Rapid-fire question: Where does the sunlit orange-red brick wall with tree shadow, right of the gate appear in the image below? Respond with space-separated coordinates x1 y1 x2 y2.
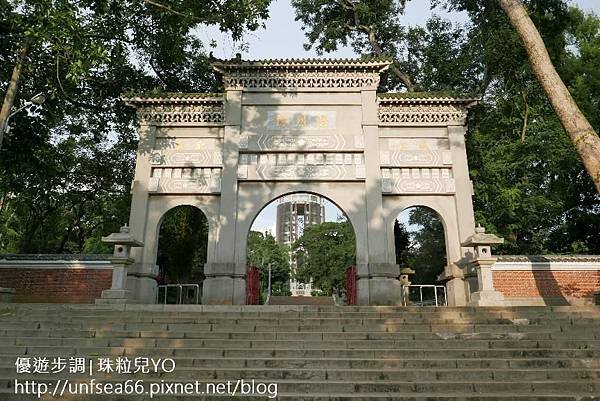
493 270 600 298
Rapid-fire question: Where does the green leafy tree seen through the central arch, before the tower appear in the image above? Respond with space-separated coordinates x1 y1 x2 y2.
292 221 356 295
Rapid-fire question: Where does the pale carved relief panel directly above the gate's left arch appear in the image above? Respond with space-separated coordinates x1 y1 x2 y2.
148 168 221 194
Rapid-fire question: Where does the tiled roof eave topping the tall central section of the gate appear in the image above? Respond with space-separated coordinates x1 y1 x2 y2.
211 57 392 75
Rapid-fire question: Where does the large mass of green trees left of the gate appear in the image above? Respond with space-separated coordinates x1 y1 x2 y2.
0 0 270 253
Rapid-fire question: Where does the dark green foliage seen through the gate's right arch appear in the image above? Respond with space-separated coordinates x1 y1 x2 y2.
394 207 447 284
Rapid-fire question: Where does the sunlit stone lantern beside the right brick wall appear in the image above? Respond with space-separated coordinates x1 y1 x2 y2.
461 226 504 306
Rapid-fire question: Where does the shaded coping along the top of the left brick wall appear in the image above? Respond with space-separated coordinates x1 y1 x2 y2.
0 254 112 269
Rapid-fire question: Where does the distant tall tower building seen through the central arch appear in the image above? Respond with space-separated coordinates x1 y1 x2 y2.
276 194 325 296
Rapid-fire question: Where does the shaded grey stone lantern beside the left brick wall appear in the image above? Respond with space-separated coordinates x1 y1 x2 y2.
96 224 144 304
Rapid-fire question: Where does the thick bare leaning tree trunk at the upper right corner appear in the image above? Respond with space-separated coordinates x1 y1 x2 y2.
498 0 600 193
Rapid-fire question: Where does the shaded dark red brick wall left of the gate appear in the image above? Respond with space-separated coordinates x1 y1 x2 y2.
0 268 112 303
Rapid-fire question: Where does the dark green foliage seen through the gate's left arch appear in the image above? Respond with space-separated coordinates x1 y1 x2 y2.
157 206 208 283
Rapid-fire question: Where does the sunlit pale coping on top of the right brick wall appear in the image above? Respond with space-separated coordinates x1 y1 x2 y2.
492 255 600 271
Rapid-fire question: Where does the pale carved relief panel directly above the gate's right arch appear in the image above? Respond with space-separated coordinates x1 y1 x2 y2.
381 168 456 194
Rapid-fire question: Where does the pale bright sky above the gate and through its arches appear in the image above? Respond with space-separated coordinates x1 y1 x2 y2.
198 0 600 234
